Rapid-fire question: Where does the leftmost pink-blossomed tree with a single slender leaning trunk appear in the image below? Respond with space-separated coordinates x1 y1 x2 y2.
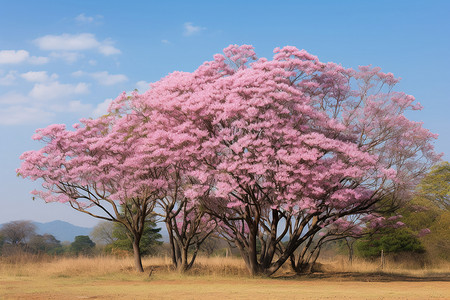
17 104 164 272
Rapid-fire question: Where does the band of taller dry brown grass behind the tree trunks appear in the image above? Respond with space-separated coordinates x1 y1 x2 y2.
0 253 450 277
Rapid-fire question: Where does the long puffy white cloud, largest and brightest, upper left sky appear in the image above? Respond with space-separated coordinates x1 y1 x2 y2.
34 33 120 55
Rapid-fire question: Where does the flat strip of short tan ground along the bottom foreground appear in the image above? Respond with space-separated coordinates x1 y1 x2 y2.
0 274 450 299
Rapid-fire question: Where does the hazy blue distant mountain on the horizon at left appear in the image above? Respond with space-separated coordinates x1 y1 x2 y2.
33 221 92 242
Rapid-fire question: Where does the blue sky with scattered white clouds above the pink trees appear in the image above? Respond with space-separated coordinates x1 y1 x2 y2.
0 0 450 226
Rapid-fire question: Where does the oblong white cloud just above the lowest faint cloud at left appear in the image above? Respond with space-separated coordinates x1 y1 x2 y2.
29 81 89 100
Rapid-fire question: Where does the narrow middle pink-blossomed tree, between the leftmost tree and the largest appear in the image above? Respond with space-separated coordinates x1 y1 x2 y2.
111 91 217 272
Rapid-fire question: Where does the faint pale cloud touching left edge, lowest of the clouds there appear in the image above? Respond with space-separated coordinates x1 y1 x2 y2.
0 106 54 125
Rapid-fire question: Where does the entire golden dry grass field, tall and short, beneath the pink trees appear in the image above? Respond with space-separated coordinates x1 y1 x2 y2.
0 257 450 300
